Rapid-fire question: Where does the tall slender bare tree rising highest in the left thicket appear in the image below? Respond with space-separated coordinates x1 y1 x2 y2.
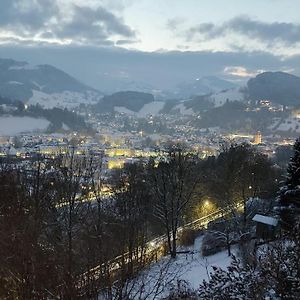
54 147 98 299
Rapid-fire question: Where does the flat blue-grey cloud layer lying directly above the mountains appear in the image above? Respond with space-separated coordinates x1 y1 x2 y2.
0 46 300 91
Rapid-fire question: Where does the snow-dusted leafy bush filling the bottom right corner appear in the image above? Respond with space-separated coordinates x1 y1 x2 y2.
198 223 300 300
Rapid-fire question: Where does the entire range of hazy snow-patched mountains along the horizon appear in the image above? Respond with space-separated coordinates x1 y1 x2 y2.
0 58 300 115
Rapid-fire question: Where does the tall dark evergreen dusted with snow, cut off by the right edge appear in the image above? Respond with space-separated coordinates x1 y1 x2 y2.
278 138 300 229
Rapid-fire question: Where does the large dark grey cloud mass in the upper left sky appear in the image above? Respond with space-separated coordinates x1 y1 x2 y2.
0 0 136 46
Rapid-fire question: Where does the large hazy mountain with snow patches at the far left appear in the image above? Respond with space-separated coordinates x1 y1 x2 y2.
0 59 100 107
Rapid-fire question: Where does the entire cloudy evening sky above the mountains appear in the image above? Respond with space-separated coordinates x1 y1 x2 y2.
0 0 300 88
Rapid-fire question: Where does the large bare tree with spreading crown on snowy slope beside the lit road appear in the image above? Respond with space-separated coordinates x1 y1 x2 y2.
151 148 200 258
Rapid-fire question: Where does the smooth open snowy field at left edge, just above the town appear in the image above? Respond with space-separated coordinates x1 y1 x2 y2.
0 117 50 135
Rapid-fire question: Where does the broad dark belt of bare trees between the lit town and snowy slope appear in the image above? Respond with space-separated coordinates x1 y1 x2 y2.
0 145 282 299
